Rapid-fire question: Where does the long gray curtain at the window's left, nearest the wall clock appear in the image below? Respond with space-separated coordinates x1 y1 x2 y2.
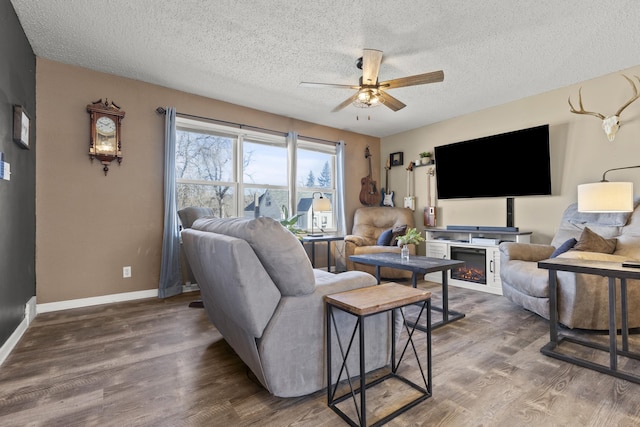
158 107 182 298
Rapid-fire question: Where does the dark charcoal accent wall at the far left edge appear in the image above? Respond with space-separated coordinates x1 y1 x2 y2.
0 0 36 346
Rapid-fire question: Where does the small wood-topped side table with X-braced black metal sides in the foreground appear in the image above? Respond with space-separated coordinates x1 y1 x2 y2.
324 283 432 426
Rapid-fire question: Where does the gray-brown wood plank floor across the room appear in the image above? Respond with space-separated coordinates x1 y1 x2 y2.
0 283 640 426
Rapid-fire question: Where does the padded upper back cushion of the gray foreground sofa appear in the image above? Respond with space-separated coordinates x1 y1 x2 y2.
192 217 316 296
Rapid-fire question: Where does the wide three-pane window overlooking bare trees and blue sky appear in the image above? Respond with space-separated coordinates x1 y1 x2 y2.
176 117 336 231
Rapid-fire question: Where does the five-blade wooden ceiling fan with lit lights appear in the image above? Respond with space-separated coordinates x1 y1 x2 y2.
300 49 444 112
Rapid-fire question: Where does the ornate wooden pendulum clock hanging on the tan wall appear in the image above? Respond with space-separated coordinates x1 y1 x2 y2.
87 98 124 176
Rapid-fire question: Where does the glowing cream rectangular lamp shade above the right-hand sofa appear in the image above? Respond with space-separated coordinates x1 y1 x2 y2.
578 182 633 212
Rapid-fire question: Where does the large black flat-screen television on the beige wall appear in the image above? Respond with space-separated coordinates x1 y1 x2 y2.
434 125 551 199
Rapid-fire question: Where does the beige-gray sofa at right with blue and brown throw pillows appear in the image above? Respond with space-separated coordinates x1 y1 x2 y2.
500 201 640 330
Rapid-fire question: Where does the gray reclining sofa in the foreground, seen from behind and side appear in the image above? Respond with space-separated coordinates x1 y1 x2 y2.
182 218 399 397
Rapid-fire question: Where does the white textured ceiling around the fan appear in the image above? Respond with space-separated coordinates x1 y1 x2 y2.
11 0 640 137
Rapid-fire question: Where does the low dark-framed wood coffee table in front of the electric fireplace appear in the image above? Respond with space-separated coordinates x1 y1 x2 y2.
349 252 464 329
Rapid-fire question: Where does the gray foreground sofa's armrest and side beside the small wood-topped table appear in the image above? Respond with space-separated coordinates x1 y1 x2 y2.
258 271 400 397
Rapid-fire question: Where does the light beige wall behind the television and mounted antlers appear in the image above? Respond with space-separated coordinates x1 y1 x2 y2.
381 66 640 250
